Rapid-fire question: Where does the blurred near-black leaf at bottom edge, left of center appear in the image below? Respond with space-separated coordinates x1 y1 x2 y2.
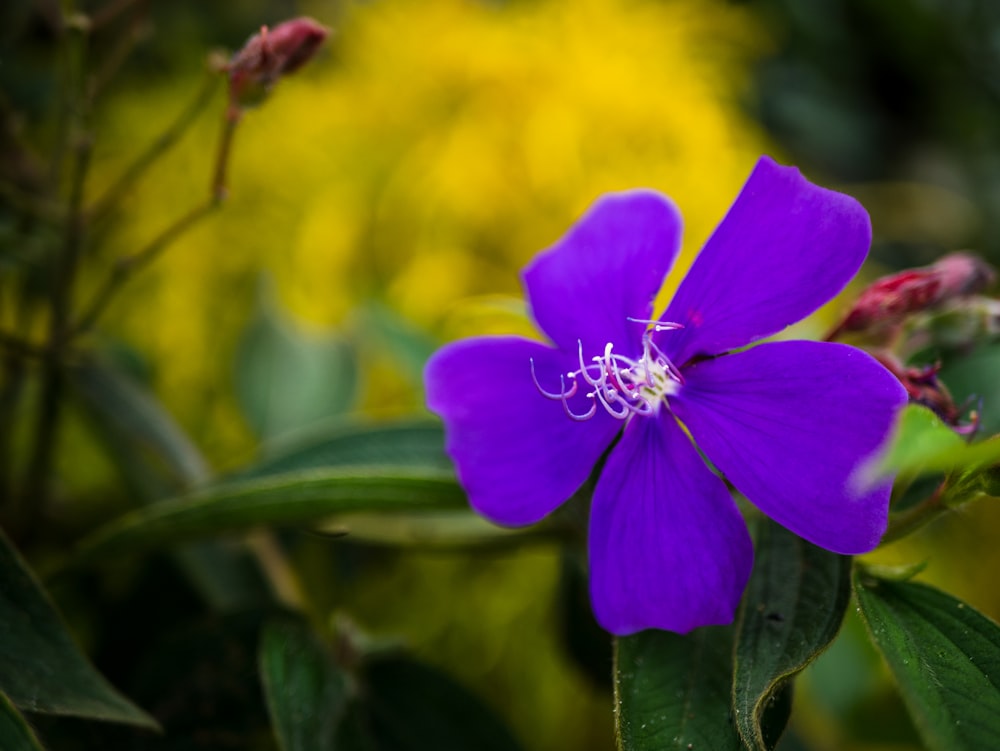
337 656 521 751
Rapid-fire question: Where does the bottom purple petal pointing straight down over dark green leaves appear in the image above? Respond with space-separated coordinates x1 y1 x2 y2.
590 411 753 635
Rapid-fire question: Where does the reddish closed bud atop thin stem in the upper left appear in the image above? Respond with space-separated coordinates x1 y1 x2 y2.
227 17 330 108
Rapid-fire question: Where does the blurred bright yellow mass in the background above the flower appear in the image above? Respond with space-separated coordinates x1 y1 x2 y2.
92 0 767 464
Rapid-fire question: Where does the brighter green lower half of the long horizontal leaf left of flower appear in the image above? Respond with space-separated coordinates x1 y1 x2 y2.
74 467 466 559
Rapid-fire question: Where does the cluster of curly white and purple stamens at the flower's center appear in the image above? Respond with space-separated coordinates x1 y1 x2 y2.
531 319 684 420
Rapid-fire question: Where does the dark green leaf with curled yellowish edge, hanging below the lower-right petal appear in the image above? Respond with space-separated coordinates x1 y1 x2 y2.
733 519 851 751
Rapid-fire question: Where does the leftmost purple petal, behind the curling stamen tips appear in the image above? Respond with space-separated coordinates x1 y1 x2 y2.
424 337 621 526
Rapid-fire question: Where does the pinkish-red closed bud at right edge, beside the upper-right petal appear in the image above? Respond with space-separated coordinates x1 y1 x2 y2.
840 253 995 331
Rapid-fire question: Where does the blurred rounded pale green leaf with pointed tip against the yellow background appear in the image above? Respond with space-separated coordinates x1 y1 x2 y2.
236 301 357 440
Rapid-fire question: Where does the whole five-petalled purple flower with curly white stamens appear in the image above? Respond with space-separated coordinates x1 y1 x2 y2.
425 157 906 634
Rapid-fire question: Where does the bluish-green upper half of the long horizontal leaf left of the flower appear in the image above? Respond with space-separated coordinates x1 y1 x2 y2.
229 420 452 479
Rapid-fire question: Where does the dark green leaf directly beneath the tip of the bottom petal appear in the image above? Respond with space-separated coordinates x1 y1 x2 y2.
615 626 743 751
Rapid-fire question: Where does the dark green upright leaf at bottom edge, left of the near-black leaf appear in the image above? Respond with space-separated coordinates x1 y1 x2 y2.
258 620 348 751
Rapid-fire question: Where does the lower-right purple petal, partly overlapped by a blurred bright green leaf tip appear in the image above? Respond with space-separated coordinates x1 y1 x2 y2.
671 342 906 554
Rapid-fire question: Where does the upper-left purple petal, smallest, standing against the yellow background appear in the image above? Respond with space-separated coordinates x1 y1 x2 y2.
523 190 681 355
